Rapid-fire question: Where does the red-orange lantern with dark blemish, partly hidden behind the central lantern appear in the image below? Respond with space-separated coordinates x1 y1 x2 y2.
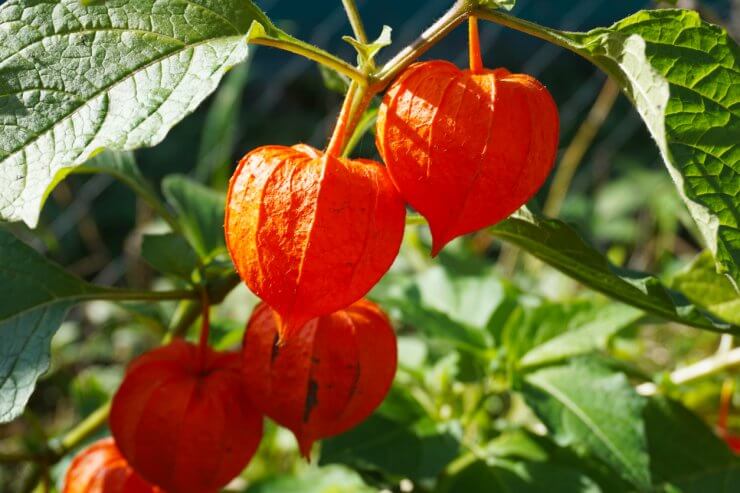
242 300 397 458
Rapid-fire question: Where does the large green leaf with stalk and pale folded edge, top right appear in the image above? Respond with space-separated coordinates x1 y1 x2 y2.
482 9 740 287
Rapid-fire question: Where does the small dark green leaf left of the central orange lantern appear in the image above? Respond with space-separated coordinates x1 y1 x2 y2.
141 233 198 281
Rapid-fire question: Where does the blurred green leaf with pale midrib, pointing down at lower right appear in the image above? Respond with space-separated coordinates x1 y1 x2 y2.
523 359 650 490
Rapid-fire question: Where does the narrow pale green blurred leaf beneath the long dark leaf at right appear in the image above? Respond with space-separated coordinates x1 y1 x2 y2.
519 304 643 367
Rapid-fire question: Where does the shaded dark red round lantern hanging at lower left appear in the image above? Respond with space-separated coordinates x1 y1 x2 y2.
110 341 262 493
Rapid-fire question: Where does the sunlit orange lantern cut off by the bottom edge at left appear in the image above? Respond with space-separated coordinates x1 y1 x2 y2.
62 438 164 493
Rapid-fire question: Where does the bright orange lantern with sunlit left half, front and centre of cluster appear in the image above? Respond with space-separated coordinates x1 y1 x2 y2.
225 145 406 337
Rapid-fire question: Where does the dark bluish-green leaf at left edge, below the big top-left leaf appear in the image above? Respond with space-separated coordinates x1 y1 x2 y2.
0 228 107 423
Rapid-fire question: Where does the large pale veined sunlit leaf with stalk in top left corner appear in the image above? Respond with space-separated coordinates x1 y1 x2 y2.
0 0 341 225
